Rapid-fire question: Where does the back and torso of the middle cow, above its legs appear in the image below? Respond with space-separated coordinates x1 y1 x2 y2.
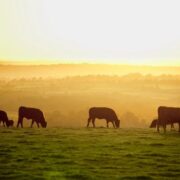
89 107 117 119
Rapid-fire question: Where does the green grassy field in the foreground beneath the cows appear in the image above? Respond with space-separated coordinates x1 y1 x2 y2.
0 127 180 180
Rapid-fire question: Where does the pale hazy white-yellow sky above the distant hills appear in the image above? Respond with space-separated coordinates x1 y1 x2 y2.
0 0 180 65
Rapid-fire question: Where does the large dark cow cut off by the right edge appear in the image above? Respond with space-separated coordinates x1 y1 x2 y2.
157 106 180 132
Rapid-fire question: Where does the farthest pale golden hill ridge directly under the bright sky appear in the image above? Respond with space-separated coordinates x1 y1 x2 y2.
0 64 180 79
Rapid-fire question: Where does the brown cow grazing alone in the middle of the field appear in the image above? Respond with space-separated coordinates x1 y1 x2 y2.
87 107 120 128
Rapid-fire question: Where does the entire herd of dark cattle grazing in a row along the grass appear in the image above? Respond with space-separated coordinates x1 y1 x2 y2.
0 106 180 132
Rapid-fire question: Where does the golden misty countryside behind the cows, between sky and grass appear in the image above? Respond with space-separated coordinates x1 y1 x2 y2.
0 64 180 128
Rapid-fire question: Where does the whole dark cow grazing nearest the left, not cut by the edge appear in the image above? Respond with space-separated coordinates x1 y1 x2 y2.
17 106 47 128
